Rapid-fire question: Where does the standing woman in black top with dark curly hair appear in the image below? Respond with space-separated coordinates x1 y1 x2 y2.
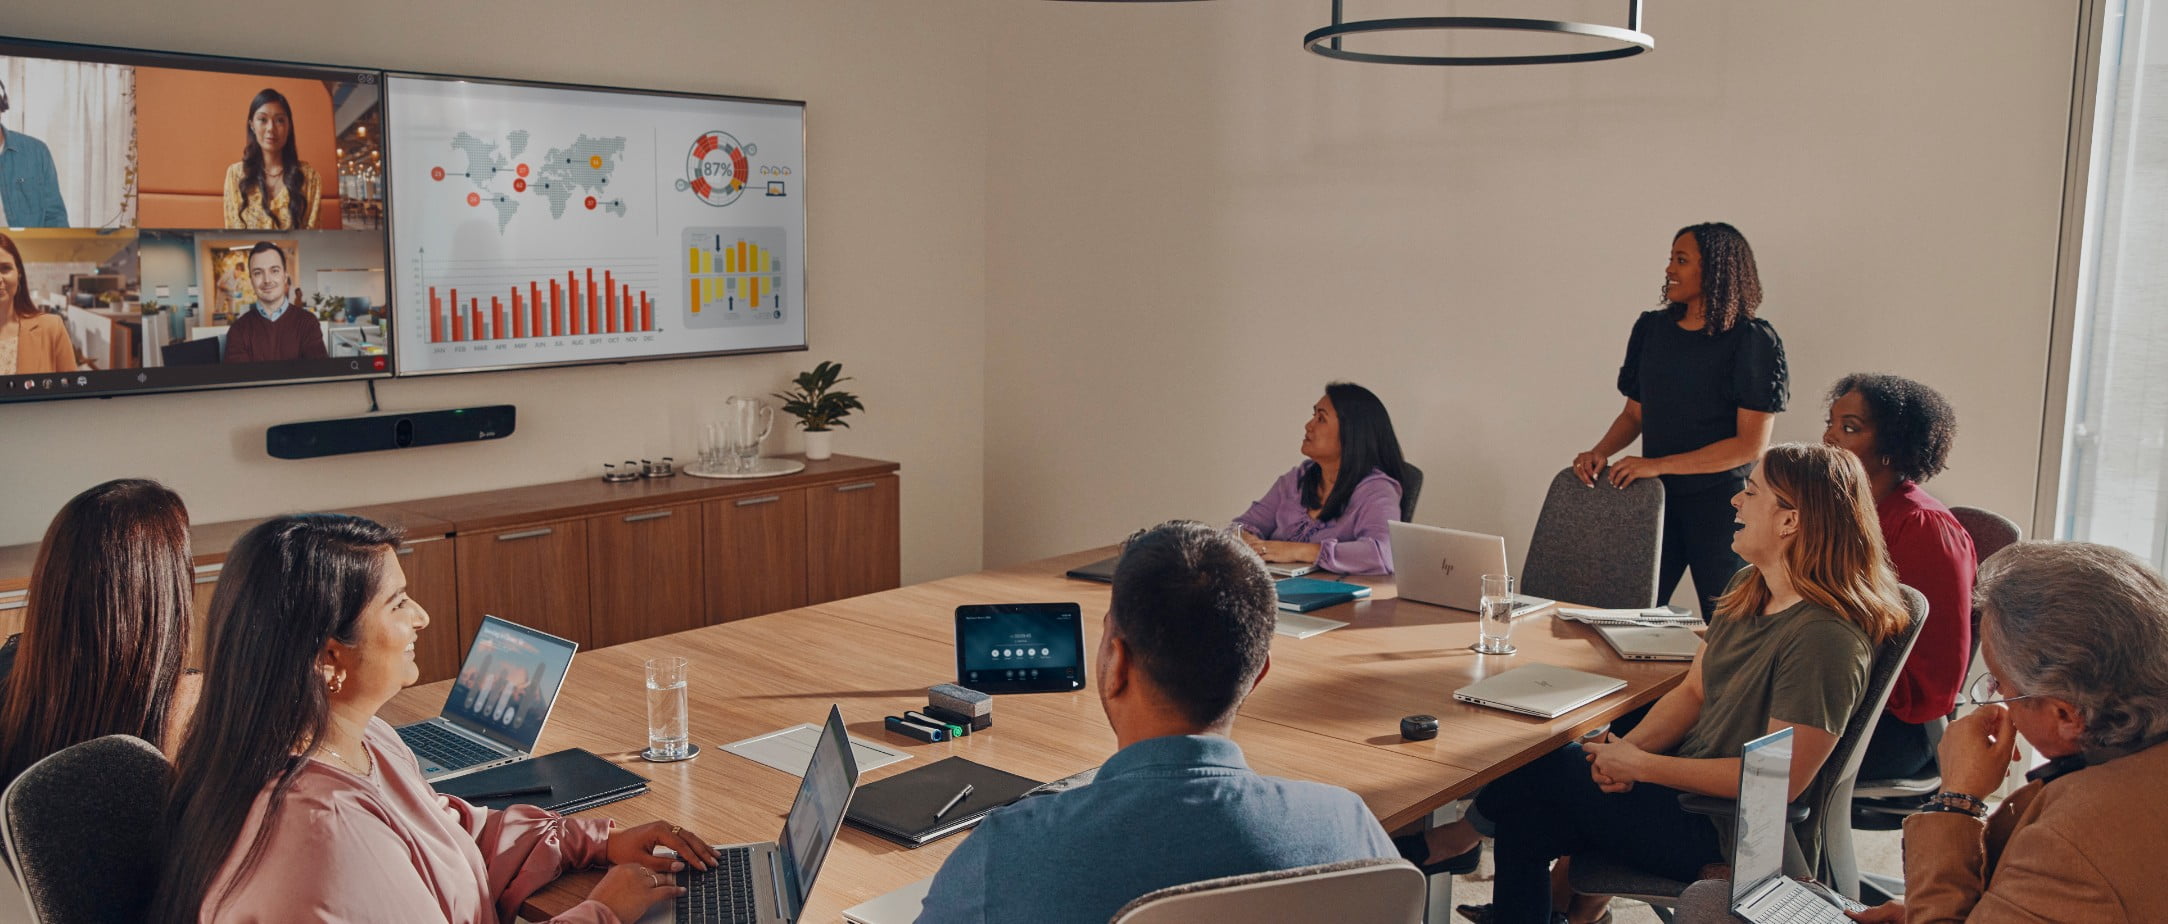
1574 221 1789 620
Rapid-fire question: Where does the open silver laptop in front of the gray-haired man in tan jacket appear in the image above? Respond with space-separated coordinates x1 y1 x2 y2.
1732 729 1860 924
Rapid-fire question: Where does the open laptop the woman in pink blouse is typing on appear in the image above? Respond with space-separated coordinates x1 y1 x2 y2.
640 705 859 924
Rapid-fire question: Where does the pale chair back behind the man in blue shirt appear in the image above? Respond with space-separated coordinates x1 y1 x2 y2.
1114 859 1427 924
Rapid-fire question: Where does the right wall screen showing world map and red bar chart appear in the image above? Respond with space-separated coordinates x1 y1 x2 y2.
386 74 806 375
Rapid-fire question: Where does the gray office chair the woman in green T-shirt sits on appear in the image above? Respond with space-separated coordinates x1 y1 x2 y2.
1567 586 1927 922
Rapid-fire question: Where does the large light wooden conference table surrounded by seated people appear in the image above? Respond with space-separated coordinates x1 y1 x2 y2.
382 547 1685 922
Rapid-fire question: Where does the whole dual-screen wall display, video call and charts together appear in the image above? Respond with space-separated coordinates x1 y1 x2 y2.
0 37 806 401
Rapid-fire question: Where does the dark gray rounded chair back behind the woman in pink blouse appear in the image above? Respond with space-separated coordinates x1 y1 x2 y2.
0 735 173 924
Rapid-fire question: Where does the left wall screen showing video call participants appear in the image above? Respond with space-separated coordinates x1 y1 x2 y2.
0 39 392 401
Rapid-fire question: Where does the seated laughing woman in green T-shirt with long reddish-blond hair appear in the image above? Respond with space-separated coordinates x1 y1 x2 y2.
1463 442 1908 924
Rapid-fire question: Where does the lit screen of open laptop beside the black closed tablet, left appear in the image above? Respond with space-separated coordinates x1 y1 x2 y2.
444 616 579 750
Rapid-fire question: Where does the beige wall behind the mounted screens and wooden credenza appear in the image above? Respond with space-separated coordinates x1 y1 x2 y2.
0 0 986 581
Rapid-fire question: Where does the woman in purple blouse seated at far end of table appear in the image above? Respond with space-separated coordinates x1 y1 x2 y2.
1234 382 1403 575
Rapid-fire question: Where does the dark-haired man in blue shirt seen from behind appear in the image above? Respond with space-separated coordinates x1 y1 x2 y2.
919 523 1398 924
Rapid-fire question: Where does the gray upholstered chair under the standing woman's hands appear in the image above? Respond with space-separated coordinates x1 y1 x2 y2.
1520 469 1663 609
